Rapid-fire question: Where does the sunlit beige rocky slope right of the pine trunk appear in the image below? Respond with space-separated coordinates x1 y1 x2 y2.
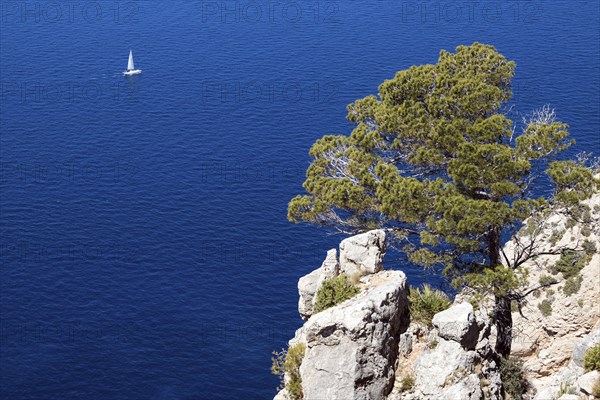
506 194 600 400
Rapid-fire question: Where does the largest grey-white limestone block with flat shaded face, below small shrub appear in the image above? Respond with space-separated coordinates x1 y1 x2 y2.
300 271 408 400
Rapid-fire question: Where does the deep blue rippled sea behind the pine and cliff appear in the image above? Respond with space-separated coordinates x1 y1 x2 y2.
0 0 600 400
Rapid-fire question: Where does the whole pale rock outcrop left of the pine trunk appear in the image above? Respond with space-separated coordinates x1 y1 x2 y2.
275 230 500 400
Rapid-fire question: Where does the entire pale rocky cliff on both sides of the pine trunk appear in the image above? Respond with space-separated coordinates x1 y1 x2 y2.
276 194 600 400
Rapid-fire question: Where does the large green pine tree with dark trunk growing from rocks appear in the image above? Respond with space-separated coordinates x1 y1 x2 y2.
288 43 600 356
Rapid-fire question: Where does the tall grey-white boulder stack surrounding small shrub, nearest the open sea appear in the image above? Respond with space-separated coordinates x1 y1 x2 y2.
276 231 408 400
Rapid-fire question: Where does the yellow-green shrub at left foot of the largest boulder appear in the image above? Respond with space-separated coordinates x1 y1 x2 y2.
271 343 306 400
